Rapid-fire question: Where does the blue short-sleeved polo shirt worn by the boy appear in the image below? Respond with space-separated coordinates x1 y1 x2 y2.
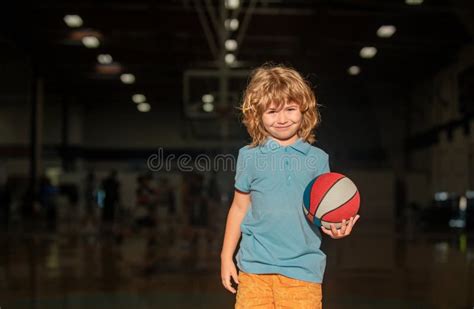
235 138 329 283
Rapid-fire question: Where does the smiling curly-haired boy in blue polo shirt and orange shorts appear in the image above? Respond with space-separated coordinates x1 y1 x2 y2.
221 66 359 309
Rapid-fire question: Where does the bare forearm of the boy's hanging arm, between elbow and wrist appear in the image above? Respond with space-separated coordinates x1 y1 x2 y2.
221 206 246 259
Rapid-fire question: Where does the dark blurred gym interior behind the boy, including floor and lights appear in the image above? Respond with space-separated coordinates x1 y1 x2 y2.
0 0 474 309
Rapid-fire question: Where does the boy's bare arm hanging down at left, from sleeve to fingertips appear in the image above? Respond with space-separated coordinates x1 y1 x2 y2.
221 190 250 293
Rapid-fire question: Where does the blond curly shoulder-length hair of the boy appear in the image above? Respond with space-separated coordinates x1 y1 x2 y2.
240 64 320 146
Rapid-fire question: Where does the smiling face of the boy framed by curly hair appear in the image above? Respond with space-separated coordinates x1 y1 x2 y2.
262 102 303 144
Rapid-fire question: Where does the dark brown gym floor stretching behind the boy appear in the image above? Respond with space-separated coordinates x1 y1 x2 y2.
0 221 474 309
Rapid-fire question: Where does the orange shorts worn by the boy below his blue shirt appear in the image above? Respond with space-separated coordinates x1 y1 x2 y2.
235 272 323 309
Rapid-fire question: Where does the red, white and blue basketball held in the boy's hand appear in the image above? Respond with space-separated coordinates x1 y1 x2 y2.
303 173 360 229
